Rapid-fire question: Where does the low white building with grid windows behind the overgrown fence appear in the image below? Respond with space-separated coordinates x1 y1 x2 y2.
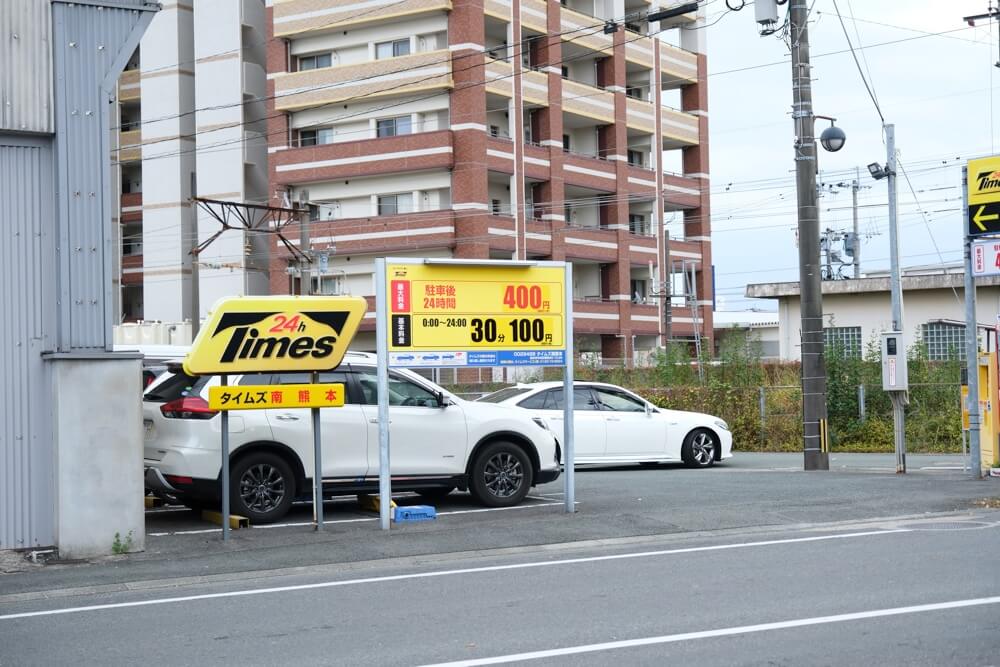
746 265 1000 360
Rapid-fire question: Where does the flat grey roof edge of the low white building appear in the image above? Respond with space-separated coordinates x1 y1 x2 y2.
746 265 1000 299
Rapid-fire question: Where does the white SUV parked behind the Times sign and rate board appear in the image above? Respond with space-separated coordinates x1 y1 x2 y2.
143 353 560 523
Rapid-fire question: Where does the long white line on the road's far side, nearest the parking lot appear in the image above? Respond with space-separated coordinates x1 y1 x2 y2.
0 528 913 621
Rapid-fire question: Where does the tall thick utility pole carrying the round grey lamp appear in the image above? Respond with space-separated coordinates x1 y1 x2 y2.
788 0 830 470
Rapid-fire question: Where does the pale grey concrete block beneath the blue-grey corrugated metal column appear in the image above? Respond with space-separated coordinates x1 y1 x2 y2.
49 358 146 558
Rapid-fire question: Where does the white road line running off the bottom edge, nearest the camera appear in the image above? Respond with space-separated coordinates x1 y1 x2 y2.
424 596 1000 667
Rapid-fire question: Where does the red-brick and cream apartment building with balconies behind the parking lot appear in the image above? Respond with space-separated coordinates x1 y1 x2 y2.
258 0 712 360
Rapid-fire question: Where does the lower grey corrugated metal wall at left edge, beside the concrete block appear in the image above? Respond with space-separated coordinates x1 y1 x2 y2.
0 134 55 549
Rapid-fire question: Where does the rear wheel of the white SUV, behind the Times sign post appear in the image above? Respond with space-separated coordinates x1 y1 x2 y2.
229 452 295 523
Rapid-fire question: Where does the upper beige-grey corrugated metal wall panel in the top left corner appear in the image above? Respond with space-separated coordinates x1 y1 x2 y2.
0 0 53 132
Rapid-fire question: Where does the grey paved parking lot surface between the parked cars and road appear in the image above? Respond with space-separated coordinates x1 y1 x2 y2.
0 454 1000 595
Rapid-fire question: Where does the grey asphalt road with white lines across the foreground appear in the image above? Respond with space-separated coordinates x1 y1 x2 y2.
0 510 1000 666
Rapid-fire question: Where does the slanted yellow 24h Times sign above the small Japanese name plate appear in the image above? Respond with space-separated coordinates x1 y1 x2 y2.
184 296 367 375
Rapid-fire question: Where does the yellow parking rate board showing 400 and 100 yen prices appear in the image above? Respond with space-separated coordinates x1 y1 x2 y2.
386 262 566 367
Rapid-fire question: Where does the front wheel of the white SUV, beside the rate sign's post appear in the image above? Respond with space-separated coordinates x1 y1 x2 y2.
469 442 534 507
